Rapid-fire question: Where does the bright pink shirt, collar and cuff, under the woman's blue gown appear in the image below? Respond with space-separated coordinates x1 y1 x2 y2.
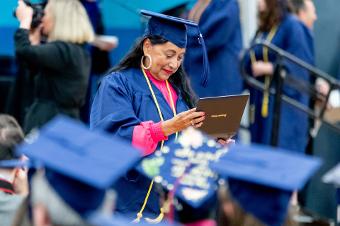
132 70 178 155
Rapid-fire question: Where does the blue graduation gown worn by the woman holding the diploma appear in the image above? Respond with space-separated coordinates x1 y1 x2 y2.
90 68 189 217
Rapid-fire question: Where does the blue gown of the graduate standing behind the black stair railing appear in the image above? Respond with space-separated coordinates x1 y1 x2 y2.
245 14 313 153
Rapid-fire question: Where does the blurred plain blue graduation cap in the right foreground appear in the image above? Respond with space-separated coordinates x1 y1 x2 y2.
211 145 321 226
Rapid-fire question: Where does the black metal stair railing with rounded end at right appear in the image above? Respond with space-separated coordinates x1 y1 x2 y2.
240 40 340 146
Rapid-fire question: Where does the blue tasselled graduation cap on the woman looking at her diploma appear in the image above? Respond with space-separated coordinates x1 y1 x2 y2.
141 10 210 86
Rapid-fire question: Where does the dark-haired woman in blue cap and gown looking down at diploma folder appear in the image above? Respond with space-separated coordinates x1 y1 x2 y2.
90 10 212 220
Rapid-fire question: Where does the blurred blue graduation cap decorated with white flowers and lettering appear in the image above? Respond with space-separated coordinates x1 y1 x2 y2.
138 128 227 209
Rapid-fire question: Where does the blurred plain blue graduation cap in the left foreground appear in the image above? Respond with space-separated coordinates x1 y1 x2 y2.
17 116 140 216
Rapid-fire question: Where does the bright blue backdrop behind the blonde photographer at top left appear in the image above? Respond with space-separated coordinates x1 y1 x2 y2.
0 0 191 59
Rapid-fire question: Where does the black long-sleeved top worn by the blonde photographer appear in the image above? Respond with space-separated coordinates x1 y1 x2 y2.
15 29 91 132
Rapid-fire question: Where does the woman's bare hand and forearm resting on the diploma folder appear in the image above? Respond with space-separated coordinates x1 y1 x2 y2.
162 108 205 136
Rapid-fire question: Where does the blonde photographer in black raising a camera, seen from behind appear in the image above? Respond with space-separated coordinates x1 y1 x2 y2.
15 0 94 132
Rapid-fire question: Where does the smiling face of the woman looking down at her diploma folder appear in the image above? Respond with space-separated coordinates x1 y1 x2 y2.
143 39 185 81
